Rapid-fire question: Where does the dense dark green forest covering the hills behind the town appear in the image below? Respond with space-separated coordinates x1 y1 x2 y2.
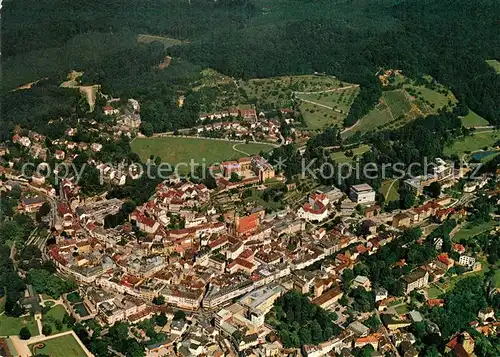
1 0 500 136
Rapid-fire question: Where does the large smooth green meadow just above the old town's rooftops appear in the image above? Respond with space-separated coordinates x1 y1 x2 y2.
131 137 273 165
